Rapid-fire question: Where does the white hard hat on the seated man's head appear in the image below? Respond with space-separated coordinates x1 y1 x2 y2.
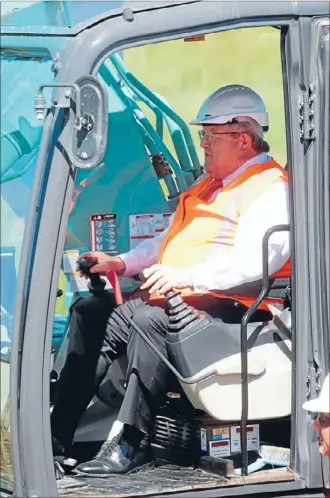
190 85 269 131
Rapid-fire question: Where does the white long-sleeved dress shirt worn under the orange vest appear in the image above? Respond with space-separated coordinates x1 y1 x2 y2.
119 153 290 291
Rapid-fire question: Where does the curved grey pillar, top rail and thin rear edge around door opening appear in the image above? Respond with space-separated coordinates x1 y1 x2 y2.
11 0 328 496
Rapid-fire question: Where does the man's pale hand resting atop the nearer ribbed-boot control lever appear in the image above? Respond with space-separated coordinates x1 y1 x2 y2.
140 265 193 295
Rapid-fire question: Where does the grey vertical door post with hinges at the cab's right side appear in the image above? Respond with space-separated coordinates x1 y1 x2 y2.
283 12 330 488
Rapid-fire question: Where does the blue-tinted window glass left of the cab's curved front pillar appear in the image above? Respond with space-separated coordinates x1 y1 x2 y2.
0 53 53 489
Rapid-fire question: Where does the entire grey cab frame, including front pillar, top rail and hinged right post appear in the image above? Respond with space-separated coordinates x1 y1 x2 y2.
2 0 330 496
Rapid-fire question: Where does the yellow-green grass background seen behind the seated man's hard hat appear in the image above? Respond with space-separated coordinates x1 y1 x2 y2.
124 28 286 164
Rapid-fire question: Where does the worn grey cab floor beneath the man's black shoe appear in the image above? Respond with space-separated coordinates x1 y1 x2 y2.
57 464 228 498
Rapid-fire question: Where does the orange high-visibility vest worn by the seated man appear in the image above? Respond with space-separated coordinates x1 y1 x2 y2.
151 159 291 310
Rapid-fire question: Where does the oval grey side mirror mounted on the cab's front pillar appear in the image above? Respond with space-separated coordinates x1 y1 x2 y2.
68 75 108 169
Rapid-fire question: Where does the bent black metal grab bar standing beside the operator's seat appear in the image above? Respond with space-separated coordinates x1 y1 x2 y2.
240 225 290 475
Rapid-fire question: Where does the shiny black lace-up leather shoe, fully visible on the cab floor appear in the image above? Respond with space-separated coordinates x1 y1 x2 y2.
76 438 152 477
